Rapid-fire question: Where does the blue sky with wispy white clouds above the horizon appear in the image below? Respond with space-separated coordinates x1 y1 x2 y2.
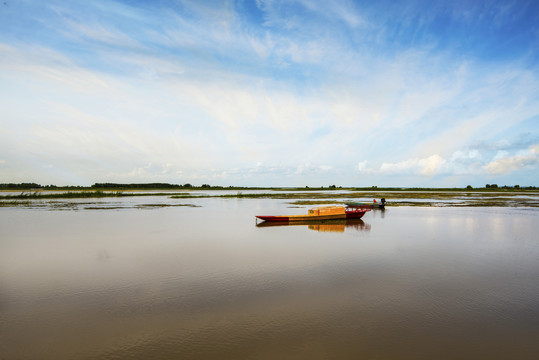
0 0 539 187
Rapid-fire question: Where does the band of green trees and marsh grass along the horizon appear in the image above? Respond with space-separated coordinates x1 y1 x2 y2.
0 183 539 209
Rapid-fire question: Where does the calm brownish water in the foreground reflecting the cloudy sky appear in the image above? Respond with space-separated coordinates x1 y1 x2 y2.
0 198 539 360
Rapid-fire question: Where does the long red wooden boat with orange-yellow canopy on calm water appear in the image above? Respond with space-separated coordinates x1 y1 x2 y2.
256 205 371 222
